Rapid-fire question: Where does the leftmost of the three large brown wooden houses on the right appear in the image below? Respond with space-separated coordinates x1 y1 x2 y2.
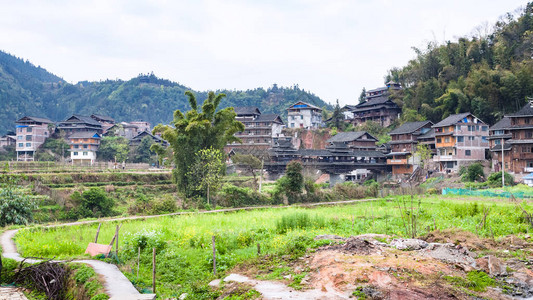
387 121 434 175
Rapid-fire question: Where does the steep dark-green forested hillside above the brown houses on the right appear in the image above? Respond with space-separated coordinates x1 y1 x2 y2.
385 3 533 124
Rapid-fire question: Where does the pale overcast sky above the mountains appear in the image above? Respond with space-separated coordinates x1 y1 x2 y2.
0 0 526 104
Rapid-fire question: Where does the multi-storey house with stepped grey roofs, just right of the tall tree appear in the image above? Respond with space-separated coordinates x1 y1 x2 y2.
226 106 284 152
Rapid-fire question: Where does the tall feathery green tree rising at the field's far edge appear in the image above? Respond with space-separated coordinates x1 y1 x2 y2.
153 91 244 197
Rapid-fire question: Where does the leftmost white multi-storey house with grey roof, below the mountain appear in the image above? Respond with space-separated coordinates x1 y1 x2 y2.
15 116 54 161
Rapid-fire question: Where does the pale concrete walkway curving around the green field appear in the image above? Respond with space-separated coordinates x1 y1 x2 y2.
0 198 379 300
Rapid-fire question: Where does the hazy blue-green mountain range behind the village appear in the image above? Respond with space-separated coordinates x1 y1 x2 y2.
0 51 331 134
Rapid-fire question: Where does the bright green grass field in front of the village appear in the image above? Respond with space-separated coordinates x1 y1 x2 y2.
16 196 533 299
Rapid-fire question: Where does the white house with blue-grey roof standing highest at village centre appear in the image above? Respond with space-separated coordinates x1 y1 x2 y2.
287 101 324 129
